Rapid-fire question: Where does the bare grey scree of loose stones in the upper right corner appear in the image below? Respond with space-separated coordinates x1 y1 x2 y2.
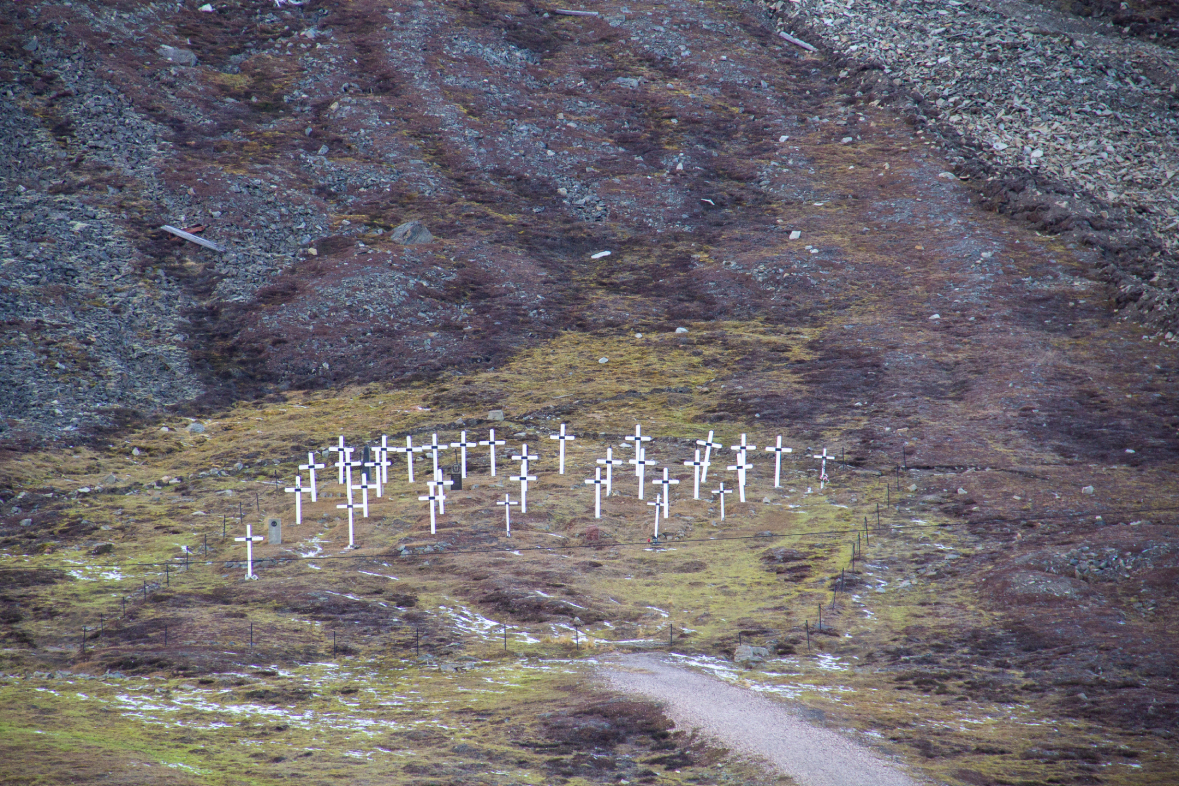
765 0 1179 333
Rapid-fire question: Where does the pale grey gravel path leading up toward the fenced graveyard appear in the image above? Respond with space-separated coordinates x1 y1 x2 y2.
602 655 917 786
